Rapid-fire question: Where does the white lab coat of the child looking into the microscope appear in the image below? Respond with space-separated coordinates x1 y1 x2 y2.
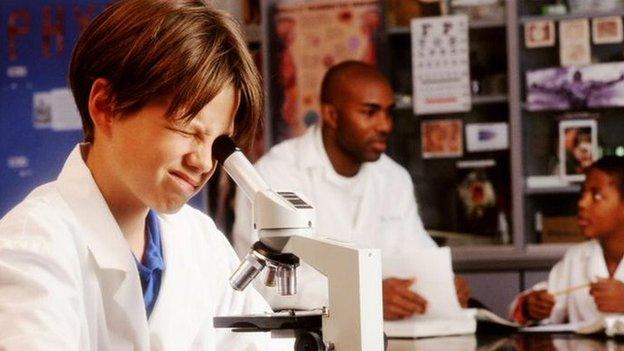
0 147 284 351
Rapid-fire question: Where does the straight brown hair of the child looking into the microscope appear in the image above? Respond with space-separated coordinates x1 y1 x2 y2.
69 0 263 146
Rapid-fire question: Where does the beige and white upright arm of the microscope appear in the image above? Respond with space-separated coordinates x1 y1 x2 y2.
284 235 384 351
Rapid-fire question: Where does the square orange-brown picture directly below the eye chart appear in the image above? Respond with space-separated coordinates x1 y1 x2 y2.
420 119 464 158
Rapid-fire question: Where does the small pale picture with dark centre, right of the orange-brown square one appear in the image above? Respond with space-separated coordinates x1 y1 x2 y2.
466 122 509 152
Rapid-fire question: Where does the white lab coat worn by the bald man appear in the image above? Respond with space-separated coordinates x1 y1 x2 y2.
232 125 435 309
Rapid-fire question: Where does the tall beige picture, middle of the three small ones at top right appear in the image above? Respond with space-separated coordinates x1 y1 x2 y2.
559 19 591 67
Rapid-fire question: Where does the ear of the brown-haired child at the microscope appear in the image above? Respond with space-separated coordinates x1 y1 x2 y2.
88 78 114 135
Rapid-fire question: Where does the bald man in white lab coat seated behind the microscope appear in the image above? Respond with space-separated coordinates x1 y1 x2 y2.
232 61 469 319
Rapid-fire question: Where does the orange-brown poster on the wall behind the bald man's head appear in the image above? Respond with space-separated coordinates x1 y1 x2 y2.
270 0 382 142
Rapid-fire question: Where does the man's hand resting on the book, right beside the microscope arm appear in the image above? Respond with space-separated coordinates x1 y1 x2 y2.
382 278 427 320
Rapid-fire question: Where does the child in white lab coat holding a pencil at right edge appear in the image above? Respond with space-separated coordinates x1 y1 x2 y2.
513 156 624 323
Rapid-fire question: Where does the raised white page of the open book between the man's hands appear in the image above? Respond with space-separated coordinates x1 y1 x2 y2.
383 247 461 317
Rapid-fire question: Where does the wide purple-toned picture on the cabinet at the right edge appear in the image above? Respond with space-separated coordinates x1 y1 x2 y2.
526 62 624 111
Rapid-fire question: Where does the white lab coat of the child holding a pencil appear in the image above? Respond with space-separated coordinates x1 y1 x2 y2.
512 240 624 324
